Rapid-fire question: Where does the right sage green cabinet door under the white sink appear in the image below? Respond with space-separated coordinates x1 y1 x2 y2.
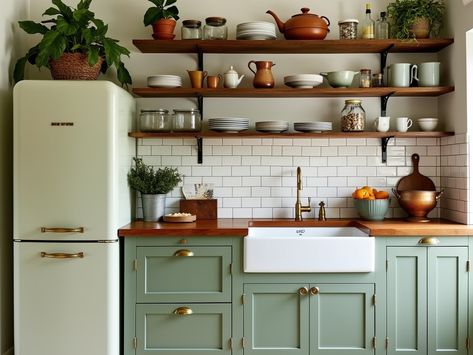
310 284 375 355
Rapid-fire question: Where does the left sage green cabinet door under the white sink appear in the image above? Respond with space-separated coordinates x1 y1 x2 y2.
243 284 309 355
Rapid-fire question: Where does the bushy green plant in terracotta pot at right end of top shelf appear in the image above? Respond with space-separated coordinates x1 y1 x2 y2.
387 0 445 39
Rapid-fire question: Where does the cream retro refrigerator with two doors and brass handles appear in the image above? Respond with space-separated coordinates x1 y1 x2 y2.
13 80 135 355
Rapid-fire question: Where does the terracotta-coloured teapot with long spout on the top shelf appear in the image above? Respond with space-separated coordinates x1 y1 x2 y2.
266 7 330 39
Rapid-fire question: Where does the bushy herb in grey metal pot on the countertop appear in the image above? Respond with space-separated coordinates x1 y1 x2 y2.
128 158 182 222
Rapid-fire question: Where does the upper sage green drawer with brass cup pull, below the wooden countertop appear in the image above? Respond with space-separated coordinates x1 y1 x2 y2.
137 246 232 303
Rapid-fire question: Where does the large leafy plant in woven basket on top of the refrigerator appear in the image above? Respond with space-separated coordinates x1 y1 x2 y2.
13 0 131 86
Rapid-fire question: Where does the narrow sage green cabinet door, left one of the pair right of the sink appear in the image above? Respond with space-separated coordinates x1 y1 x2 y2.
386 247 427 355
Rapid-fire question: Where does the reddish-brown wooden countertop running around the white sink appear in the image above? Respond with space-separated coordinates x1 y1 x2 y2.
118 218 473 237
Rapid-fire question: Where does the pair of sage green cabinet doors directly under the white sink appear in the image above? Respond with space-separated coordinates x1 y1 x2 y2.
244 283 375 355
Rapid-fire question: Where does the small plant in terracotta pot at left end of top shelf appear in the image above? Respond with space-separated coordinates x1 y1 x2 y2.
143 0 179 39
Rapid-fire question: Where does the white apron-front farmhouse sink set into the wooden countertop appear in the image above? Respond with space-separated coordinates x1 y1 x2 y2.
244 227 375 273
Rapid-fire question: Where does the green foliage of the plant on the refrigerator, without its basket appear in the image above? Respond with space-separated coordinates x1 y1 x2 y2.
13 0 131 86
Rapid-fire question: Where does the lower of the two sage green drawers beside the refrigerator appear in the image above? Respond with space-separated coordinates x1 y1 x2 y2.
136 304 232 355
